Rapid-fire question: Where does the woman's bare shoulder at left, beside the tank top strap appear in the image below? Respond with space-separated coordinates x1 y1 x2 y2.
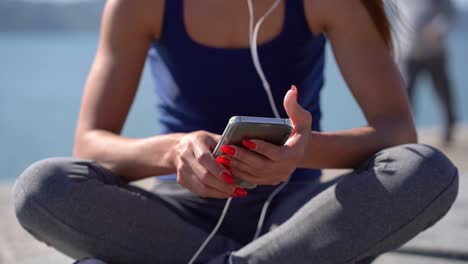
103 0 165 39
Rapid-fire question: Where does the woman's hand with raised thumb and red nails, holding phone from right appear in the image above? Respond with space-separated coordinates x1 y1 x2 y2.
217 86 312 185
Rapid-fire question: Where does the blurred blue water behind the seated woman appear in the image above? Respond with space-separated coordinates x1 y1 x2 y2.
0 29 468 181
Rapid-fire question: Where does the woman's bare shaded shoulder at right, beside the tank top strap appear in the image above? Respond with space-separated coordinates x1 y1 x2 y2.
304 0 364 33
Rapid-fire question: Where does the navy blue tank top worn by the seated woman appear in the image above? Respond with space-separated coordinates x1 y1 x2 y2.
149 0 326 180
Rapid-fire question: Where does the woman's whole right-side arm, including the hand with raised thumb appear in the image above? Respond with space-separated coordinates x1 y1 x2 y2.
224 0 416 185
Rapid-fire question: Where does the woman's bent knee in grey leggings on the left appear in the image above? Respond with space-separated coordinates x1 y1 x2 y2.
13 158 79 231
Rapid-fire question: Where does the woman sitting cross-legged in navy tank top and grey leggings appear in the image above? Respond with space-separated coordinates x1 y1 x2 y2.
15 0 458 263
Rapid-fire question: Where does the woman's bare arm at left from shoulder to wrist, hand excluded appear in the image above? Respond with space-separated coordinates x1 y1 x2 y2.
73 0 180 180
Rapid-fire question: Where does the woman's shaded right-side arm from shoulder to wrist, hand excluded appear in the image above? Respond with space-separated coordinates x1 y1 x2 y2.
299 0 417 168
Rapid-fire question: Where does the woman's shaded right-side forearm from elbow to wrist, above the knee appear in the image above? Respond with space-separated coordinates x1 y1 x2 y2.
300 118 417 168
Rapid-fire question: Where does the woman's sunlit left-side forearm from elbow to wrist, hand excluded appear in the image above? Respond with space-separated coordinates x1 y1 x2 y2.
73 130 183 181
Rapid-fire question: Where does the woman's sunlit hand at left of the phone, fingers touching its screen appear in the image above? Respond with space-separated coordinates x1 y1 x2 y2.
176 131 247 199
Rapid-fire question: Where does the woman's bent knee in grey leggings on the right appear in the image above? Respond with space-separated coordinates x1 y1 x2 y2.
382 144 458 210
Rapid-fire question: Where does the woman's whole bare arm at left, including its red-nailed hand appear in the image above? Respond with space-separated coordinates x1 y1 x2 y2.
73 0 236 198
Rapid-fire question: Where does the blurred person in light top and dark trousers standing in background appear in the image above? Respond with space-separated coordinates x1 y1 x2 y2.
396 0 457 145
